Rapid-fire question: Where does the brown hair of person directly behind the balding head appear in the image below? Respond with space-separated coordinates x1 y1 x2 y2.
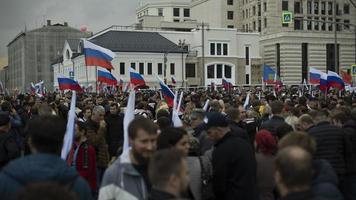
278 132 316 155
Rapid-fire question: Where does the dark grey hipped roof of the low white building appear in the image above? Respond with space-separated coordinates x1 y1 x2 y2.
90 30 186 53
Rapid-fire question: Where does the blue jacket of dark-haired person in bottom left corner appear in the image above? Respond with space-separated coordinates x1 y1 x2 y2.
0 154 92 200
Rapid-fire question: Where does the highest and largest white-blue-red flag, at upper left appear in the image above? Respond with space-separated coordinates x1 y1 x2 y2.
83 40 116 70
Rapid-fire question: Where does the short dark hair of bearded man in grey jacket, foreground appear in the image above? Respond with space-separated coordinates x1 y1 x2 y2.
128 116 157 139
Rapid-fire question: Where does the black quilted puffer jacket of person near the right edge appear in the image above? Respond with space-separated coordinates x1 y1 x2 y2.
308 122 346 178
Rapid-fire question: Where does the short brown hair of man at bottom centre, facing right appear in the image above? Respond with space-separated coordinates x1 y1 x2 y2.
148 149 184 187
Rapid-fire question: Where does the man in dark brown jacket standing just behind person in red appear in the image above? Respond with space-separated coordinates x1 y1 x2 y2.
86 106 109 185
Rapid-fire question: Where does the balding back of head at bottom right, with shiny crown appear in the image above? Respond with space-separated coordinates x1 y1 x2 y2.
275 146 313 191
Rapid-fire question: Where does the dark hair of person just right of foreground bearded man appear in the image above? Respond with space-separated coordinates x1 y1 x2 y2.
157 127 188 150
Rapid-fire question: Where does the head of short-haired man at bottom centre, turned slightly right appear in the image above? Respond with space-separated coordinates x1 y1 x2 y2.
148 149 189 200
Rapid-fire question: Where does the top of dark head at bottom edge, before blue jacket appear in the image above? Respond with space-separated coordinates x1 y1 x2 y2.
17 182 79 200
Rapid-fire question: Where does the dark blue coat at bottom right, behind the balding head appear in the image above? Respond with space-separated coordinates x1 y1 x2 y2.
312 160 344 200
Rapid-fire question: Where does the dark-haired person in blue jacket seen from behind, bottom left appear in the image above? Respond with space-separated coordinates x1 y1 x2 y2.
0 116 92 200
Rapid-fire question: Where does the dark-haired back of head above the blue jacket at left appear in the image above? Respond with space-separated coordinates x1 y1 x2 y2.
27 115 66 154
